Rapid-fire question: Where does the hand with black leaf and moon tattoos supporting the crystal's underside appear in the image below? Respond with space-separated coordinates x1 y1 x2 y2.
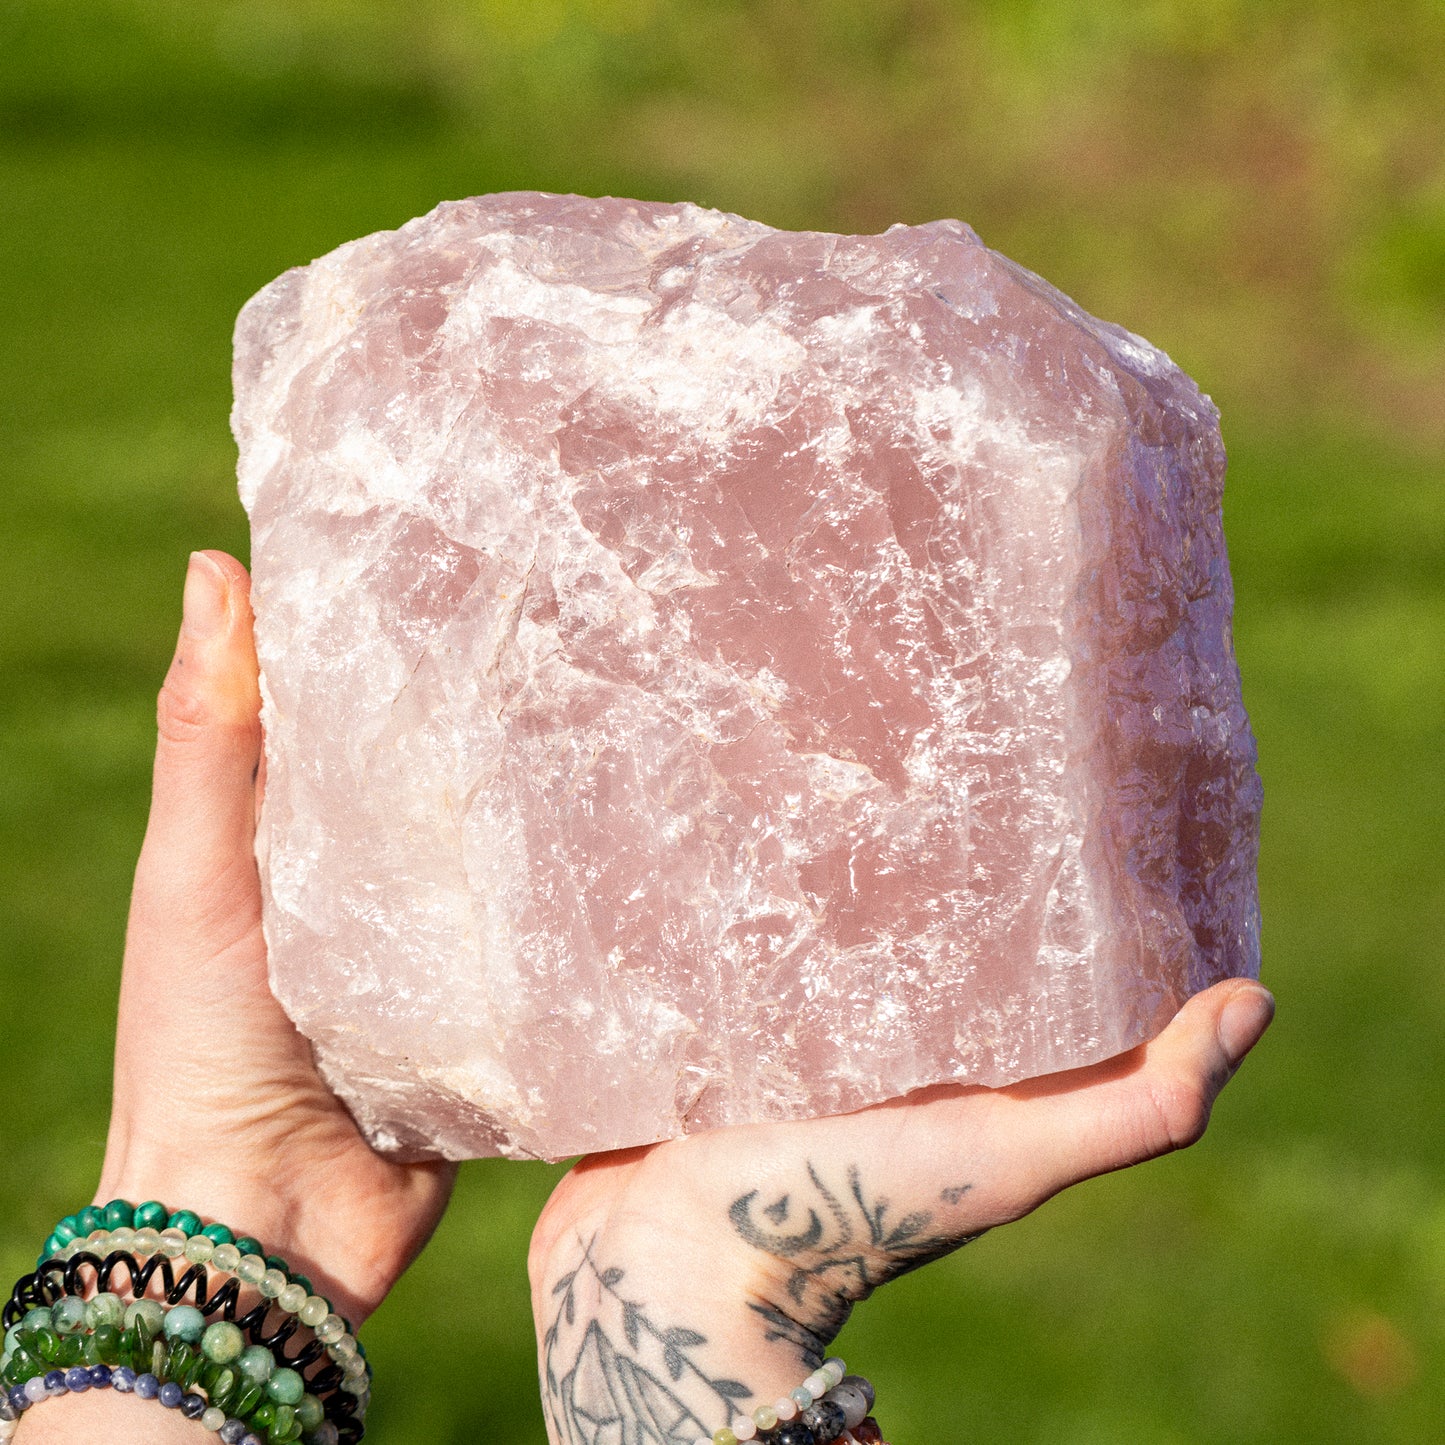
529 980 1273 1445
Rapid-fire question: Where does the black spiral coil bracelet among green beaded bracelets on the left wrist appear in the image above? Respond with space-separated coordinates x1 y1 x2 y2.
7 1251 368 1438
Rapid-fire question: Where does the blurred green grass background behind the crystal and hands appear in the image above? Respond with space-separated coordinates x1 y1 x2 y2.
0 0 1445 1445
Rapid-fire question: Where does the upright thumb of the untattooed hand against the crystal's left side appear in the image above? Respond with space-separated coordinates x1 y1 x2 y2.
131 552 262 957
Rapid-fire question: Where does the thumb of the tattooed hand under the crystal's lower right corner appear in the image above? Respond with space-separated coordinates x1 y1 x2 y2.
994 978 1274 1202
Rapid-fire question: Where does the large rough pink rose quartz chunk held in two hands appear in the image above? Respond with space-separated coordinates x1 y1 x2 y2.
234 194 1260 1159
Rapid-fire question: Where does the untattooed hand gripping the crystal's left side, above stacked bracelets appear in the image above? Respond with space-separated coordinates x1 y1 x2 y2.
95 552 454 1325
